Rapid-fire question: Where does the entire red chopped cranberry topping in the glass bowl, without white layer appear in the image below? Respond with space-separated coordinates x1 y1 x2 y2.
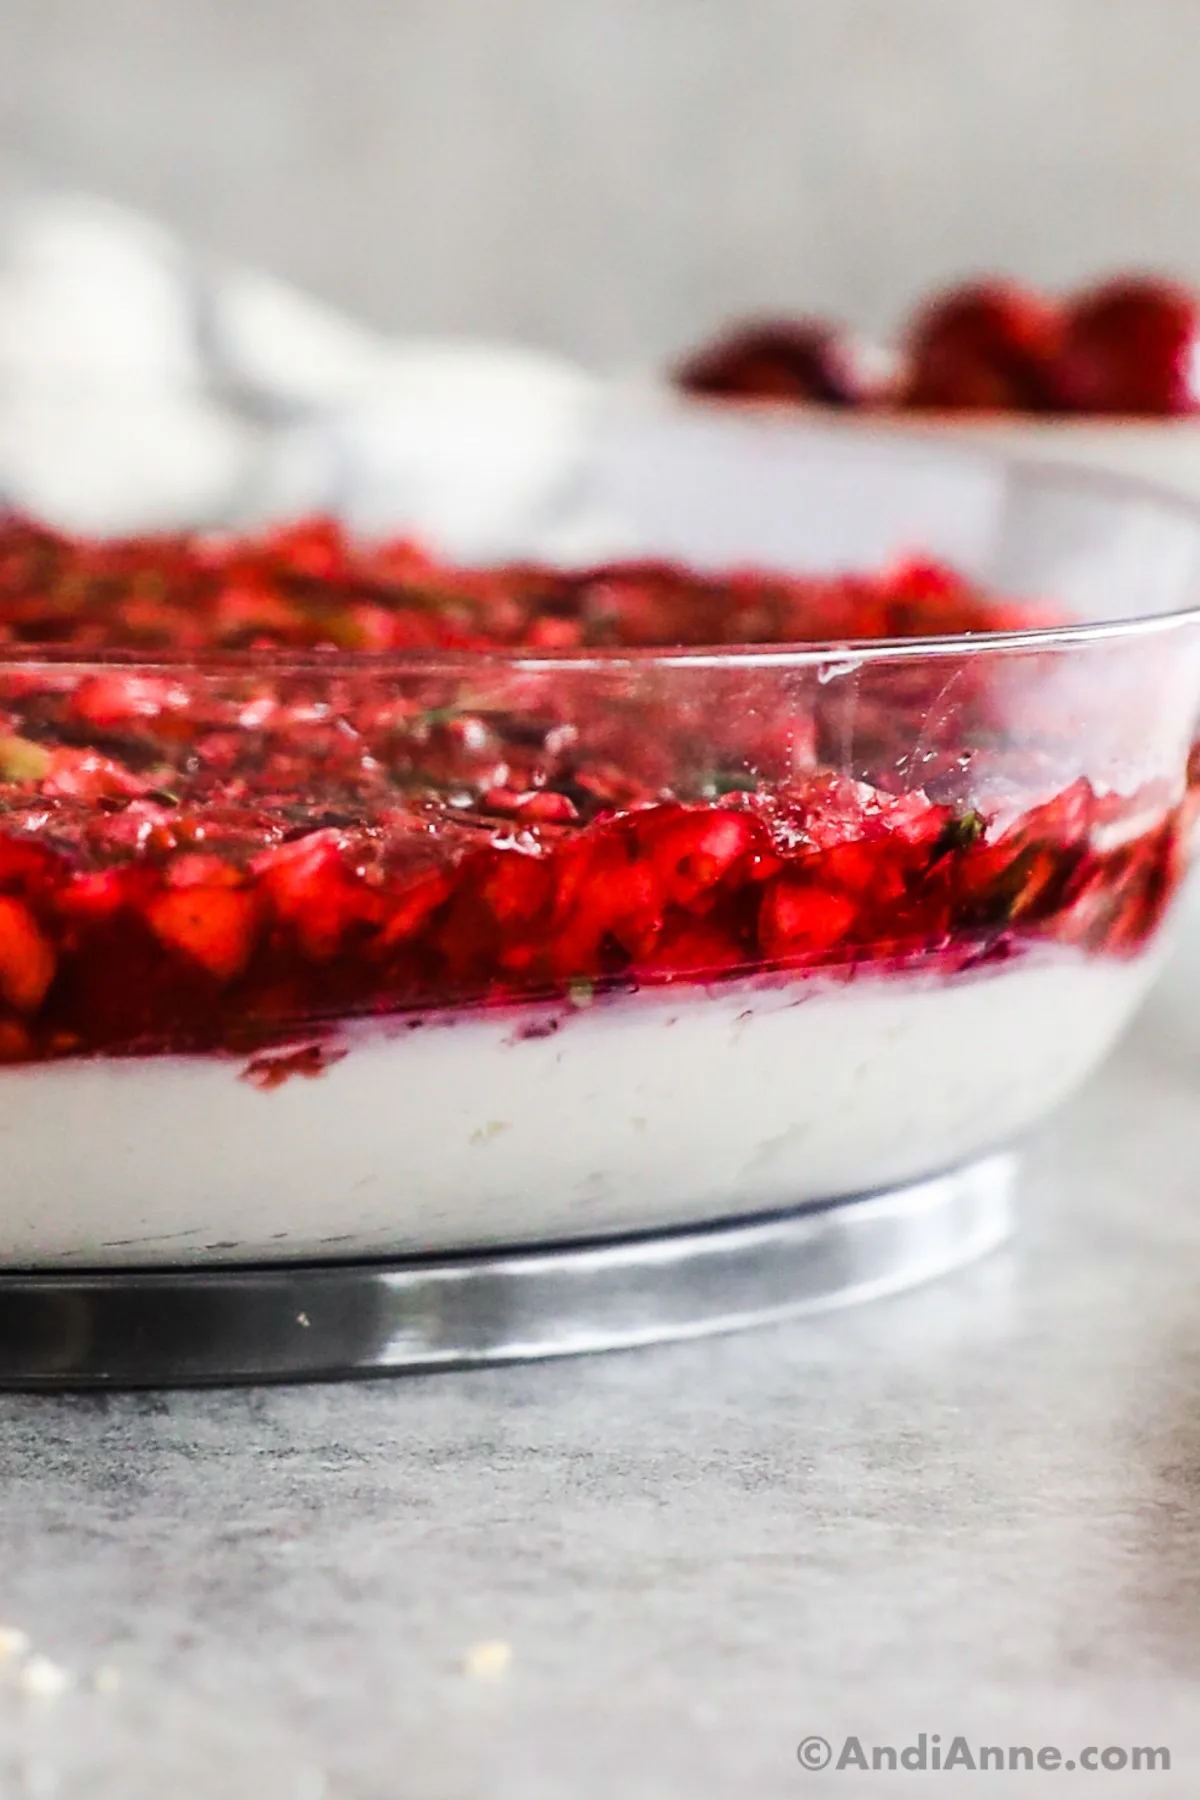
0 520 1189 1058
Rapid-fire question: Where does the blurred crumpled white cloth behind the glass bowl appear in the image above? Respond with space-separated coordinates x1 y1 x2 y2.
0 198 619 558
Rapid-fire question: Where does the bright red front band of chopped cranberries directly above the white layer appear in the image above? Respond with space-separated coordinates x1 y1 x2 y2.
0 772 1184 1058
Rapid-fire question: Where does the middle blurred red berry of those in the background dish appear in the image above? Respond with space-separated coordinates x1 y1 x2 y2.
905 281 1061 412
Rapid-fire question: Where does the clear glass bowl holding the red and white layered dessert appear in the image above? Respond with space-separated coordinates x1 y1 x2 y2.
0 403 1200 1269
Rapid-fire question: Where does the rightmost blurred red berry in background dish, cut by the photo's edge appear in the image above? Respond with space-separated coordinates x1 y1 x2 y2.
1051 277 1200 416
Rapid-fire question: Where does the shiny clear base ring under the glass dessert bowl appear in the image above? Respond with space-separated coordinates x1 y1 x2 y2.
0 1154 1015 1390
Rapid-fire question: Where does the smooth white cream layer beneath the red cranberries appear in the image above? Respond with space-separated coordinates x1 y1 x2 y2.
0 959 1151 1267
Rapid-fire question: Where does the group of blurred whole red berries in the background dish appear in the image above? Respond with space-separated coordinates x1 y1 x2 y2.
675 275 1200 418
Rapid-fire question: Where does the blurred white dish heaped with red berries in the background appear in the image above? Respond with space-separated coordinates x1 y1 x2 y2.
673 275 1200 495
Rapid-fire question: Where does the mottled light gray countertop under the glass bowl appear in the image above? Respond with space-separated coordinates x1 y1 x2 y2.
0 1019 1200 1800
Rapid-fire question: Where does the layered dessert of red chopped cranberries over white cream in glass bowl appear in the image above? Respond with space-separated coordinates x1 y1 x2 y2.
0 518 1195 1265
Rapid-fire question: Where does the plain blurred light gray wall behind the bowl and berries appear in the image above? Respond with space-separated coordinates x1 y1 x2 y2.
0 0 1200 364
